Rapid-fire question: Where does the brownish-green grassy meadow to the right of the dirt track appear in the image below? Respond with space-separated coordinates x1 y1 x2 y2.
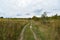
33 18 60 40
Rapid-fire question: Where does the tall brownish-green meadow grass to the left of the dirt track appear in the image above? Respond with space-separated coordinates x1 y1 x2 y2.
0 18 28 40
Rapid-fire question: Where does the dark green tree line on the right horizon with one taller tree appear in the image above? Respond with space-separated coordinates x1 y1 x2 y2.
32 12 60 20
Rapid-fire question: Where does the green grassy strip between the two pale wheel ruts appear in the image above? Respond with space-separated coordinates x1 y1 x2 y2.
23 25 35 40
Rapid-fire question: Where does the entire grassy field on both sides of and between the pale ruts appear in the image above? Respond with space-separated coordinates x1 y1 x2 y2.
0 17 60 40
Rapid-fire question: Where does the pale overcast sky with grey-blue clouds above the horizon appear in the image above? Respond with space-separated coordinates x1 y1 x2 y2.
0 0 60 18
